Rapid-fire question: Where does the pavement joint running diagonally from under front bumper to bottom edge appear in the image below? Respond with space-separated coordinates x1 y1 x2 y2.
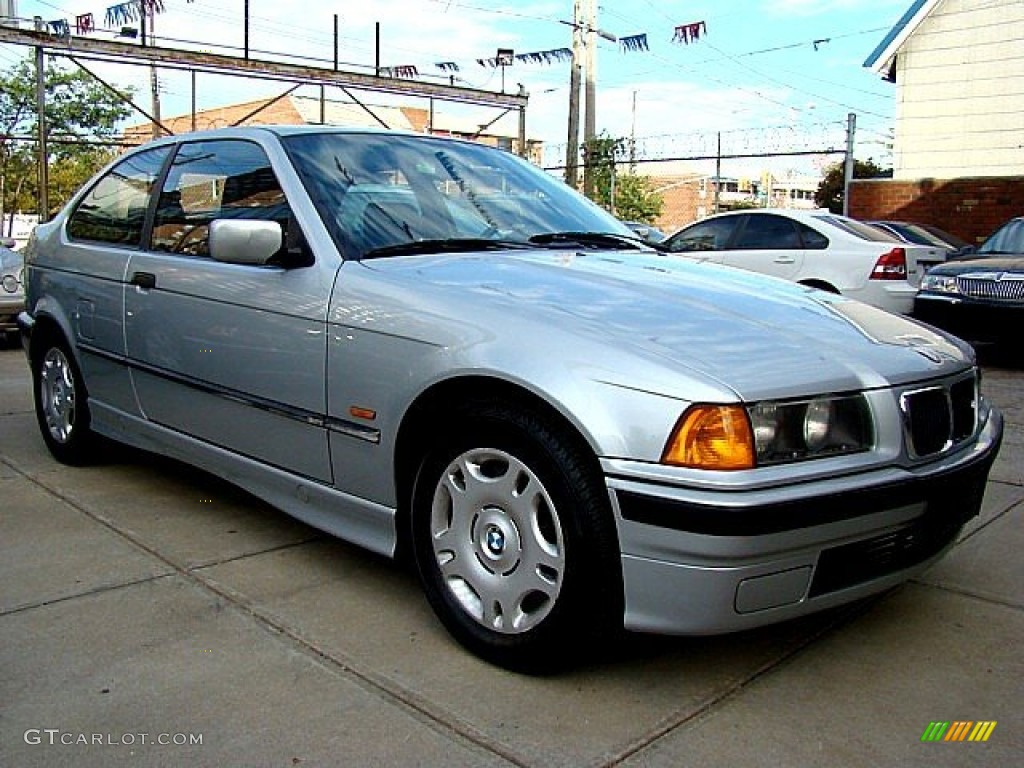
600 606 872 768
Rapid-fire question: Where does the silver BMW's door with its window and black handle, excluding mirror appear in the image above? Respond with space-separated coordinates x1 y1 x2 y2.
125 139 332 482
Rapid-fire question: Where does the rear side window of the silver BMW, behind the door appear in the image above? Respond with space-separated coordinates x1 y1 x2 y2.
68 146 170 246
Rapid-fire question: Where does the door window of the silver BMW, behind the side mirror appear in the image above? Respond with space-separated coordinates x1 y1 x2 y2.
152 139 291 256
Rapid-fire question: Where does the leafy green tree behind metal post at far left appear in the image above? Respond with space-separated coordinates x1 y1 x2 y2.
0 57 133 225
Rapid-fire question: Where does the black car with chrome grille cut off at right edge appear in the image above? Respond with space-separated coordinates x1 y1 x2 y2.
913 216 1024 348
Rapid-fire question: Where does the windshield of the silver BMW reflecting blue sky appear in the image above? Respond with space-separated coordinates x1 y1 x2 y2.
283 132 636 258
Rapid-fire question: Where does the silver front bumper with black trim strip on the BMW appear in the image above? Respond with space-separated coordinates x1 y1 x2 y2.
608 409 1002 635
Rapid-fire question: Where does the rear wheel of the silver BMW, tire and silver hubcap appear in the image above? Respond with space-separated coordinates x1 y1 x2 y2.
32 335 94 465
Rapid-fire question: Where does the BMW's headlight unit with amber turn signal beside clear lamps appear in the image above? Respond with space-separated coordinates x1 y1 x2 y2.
662 394 873 470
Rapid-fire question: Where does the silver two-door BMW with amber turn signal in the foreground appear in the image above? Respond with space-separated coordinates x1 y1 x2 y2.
20 126 1002 670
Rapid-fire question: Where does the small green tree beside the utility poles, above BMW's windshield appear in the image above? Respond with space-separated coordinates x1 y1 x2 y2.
585 132 665 224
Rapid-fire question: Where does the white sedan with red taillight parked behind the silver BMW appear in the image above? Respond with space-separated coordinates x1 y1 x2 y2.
662 209 944 314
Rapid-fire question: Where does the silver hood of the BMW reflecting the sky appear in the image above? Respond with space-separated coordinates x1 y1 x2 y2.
356 251 973 399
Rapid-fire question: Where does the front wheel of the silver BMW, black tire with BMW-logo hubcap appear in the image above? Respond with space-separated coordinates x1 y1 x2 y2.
411 401 623 674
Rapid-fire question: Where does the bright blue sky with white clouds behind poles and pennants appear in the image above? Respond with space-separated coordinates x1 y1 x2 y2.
0 0 910 177
